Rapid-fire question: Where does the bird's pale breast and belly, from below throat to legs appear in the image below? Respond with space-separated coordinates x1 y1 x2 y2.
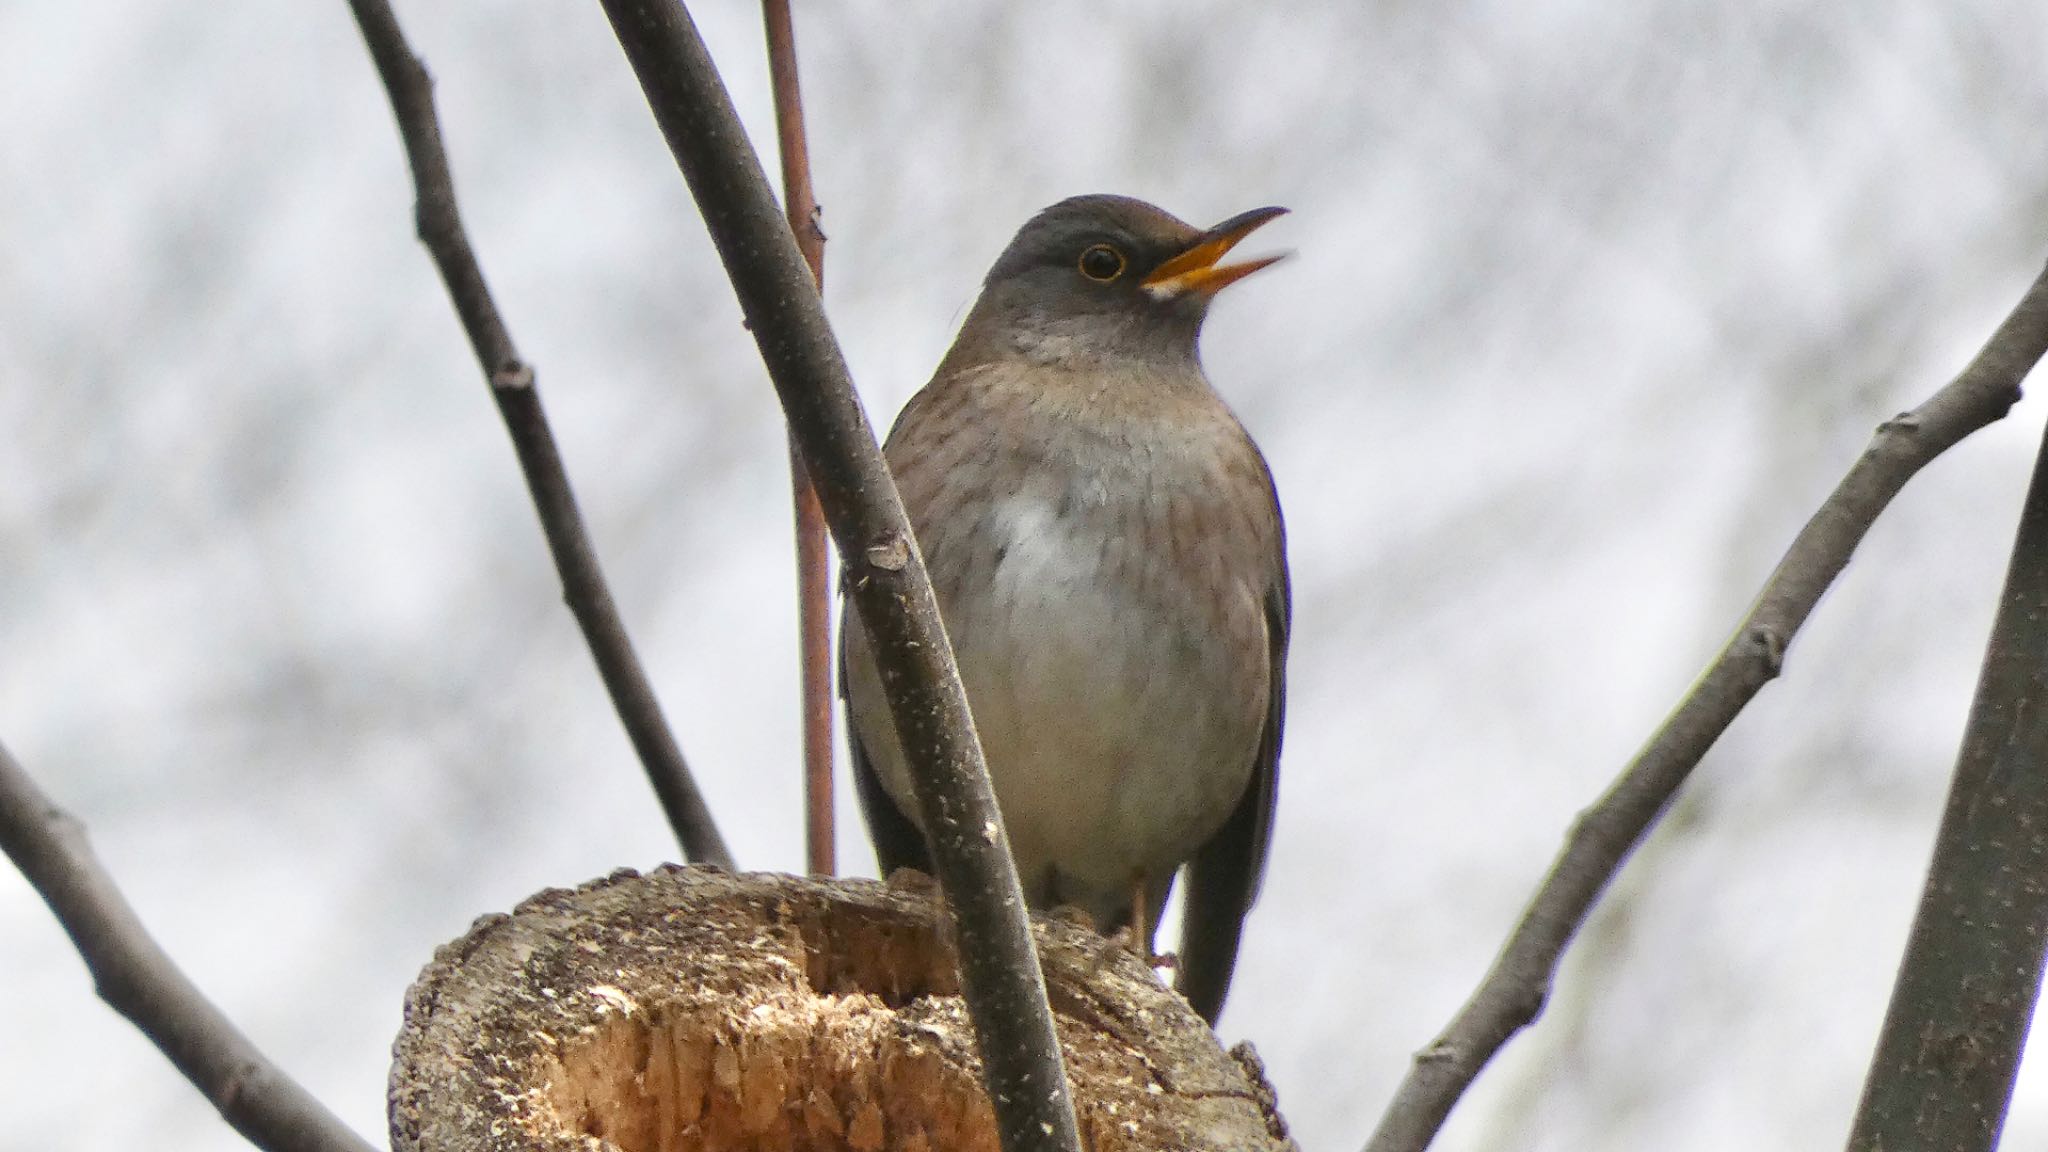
885 407 1274 916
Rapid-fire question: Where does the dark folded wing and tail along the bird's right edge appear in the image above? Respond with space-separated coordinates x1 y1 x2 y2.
1176 494 1294 1025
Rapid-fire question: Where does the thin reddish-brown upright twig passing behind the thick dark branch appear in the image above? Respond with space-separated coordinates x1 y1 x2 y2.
762 0 838 875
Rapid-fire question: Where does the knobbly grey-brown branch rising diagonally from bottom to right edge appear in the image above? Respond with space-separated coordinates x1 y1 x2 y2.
1366 258 2048 1152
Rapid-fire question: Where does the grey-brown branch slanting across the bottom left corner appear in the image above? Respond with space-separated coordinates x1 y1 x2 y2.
0 746 371 1152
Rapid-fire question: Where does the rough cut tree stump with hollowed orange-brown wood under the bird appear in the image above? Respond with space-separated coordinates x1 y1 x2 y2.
389 867 1298 1152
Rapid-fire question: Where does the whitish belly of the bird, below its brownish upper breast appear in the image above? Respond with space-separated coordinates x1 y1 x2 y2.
848 481 1270 922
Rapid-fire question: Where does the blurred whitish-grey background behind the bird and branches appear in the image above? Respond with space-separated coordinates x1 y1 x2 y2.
0 0 2048 1152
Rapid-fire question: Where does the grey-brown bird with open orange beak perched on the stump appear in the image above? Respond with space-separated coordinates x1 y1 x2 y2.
840 195 1292 1025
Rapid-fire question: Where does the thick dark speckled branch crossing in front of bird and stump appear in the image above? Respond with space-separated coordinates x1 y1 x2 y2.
604 0 1079 1152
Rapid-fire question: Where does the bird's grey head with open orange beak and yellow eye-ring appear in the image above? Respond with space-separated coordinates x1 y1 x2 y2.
954 195 1286 363
